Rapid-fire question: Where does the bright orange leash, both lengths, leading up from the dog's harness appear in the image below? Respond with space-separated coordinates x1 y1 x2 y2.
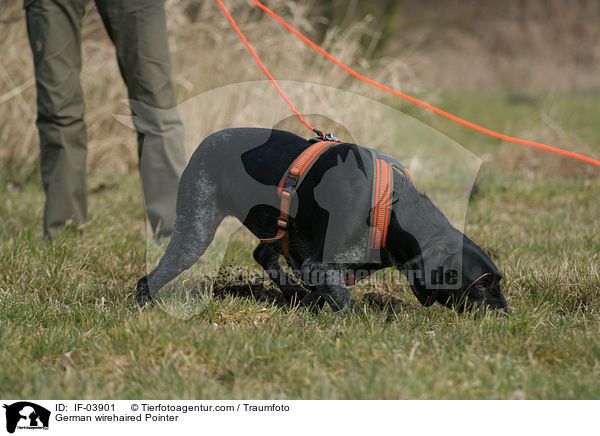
217 0 600 166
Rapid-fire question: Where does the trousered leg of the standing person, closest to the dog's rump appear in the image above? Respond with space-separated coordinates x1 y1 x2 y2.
96 0 185 237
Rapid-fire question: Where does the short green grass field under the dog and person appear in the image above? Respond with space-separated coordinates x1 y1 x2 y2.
0 94 600 399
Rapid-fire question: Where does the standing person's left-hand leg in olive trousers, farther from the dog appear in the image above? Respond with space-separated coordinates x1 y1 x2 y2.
26 0 87 237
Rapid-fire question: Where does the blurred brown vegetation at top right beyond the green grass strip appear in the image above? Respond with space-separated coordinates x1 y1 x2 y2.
387 0 600 93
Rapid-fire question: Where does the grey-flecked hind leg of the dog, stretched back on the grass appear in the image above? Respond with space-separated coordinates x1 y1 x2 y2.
135 173 225 307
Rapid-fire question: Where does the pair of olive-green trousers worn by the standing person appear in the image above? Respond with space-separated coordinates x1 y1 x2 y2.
25 0 185 237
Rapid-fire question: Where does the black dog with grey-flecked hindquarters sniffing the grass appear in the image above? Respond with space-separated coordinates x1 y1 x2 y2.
136 128 507 311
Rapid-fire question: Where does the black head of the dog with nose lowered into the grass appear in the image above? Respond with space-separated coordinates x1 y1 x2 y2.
403 235 508 312
